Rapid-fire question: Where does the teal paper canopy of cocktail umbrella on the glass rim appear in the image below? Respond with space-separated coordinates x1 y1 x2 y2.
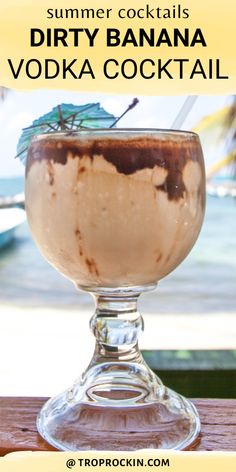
16 103 117 164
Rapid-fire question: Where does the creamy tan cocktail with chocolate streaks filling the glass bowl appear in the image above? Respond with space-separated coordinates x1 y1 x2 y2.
26 130 204 287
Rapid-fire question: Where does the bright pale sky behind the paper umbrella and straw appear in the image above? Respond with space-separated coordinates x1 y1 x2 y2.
0 90 228 177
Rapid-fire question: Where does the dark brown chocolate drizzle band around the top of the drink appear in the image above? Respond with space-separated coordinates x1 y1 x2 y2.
26 132 204 200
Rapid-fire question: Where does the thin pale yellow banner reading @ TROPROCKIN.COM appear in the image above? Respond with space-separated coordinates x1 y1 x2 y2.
0 451 236 472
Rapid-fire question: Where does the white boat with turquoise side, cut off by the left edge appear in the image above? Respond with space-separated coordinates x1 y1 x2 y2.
0 208 26 249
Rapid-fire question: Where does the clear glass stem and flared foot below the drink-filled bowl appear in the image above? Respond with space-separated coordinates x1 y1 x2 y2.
37 287 200 451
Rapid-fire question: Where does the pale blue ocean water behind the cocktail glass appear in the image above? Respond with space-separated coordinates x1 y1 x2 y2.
0 178 236 315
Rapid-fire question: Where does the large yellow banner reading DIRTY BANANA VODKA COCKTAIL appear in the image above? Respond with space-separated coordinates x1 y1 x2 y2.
0 0 236 95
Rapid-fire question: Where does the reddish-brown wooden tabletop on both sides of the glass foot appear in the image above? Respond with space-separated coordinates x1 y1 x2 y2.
0 397 236 455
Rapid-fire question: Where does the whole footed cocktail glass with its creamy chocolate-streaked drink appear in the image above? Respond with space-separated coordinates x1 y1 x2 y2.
26 129 205 450
